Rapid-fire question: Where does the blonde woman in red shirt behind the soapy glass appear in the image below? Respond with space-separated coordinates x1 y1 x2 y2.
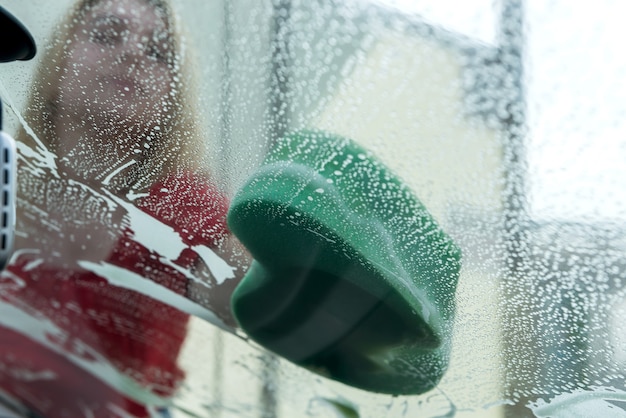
0 0 247 417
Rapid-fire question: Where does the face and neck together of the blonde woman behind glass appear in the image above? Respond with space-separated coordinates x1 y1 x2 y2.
54 0 177 189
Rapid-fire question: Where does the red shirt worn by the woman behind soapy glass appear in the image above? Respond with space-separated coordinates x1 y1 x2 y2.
0 175 228 417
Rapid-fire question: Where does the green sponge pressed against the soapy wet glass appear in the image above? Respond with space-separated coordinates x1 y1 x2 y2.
228 131 461 394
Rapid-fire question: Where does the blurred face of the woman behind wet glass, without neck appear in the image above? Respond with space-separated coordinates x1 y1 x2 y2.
58 0 174 131
